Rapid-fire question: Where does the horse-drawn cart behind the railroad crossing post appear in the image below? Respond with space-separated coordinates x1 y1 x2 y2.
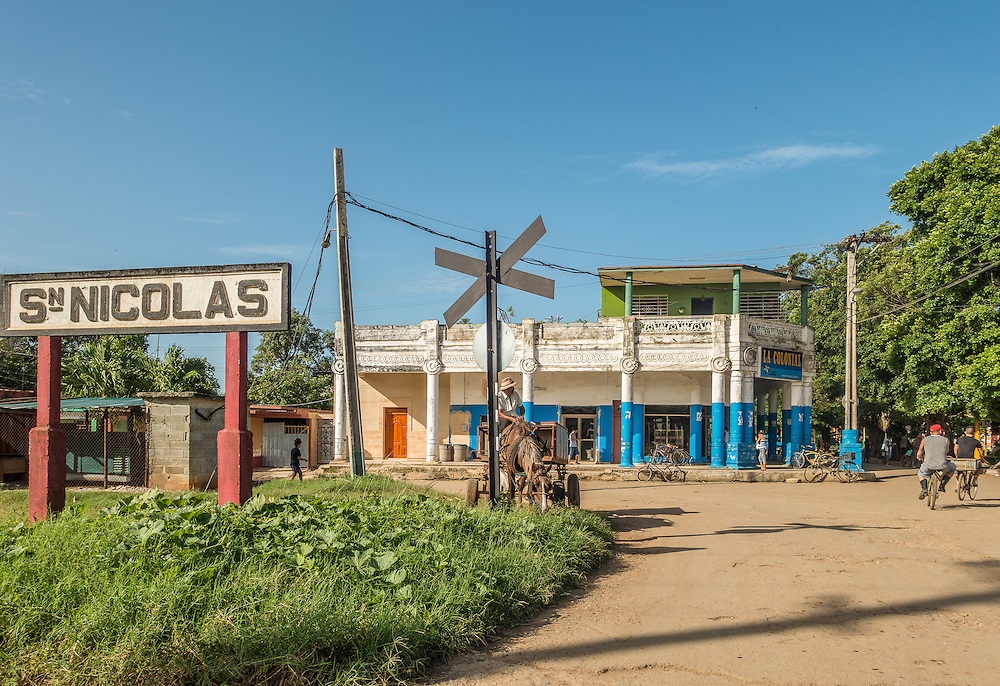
465 422 580 509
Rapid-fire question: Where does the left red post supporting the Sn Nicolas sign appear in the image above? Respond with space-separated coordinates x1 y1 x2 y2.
28 336 66 522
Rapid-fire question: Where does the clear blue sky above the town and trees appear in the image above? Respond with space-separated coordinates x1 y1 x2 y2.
0 0 1000 374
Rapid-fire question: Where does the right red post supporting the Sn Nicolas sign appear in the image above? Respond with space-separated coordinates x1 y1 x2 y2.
217 331 253 505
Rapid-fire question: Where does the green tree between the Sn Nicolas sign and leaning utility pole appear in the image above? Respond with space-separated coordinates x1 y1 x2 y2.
248 310 333 408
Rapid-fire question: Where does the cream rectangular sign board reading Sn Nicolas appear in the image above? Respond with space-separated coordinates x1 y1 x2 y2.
0 262 291 336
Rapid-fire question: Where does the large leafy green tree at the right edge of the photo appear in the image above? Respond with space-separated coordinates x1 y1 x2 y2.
888 126 1000 418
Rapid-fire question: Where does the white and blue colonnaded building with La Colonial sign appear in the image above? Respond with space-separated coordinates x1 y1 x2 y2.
344 264 816 468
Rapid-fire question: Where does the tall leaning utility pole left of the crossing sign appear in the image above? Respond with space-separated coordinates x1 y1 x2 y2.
323 148 365 476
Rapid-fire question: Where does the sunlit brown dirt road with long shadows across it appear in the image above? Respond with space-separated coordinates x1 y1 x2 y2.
422 471 1000 686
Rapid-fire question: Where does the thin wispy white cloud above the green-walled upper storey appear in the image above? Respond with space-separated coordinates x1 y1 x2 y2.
625 144 878 179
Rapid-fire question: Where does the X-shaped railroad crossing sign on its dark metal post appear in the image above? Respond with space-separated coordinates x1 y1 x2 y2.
434 217 556 507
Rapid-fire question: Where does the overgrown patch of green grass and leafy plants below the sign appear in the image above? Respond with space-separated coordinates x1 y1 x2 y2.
0 477 612 686
